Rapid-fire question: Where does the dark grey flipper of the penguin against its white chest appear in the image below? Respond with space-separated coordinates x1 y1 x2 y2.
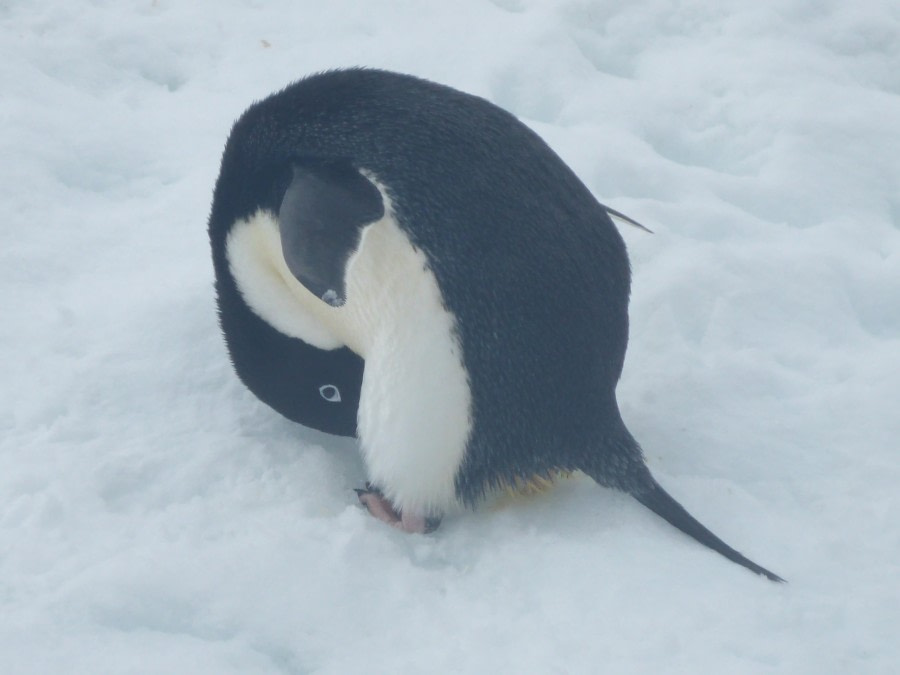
278 160 384 307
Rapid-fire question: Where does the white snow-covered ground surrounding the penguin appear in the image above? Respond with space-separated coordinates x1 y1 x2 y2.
0 0 900 675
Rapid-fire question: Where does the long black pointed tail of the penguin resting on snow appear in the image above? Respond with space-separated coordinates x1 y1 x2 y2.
582 425 785 583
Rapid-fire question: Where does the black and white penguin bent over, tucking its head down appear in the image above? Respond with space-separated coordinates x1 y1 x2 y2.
209 68 783 581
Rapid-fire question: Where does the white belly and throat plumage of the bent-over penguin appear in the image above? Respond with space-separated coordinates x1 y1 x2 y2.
227 204 472 515
